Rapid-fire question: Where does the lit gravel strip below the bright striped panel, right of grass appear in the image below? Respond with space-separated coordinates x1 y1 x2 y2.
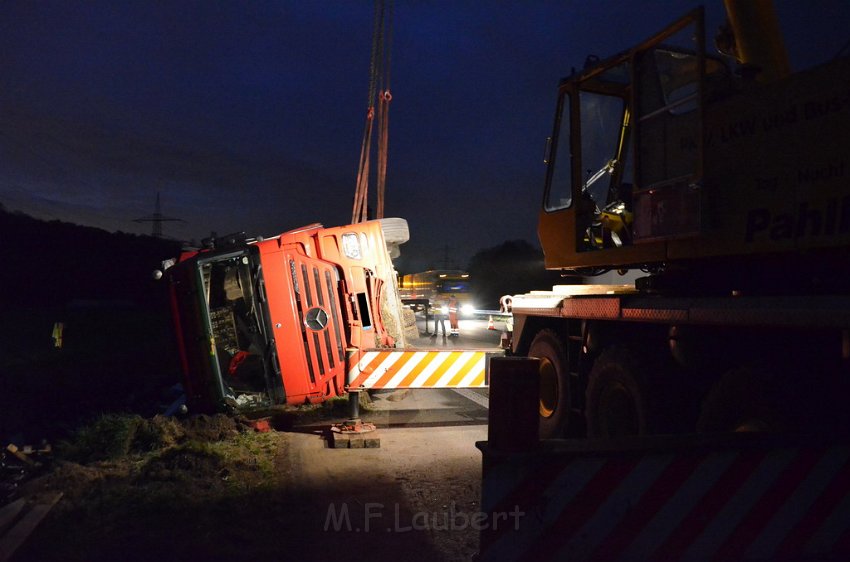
279 426 486 560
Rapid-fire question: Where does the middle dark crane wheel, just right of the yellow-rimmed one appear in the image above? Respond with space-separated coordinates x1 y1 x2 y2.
585 347 649 438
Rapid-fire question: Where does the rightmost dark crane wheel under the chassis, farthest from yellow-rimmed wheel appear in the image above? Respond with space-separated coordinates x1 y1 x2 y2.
697 367 783 433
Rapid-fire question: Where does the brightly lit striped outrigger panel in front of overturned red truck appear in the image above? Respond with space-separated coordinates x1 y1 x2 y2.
347 351 488 389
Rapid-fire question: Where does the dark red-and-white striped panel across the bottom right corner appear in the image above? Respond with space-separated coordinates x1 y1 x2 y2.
482 446 850 561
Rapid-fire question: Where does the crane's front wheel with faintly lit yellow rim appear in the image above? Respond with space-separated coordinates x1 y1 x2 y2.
528 330 570 439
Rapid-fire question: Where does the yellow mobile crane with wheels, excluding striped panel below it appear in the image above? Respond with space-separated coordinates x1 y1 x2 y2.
500 0 850 437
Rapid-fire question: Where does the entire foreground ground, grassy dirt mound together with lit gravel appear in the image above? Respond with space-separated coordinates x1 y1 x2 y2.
13 406 484 562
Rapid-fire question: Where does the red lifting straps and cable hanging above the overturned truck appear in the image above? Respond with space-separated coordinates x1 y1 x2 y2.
351 0 393 223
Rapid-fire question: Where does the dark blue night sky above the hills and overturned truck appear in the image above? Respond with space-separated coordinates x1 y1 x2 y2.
0 0 850 271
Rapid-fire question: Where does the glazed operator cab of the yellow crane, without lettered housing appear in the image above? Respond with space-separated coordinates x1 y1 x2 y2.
539 11 729 269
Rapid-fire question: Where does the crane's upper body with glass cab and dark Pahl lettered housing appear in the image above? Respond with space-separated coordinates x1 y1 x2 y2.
538 3 850 294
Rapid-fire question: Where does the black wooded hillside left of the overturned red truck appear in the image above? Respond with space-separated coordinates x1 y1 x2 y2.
0 209 180 444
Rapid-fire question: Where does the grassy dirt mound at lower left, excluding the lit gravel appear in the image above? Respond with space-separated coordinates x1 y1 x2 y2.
13 416 280 561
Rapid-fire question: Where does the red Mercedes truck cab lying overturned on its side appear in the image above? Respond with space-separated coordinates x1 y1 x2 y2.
166 219 408 412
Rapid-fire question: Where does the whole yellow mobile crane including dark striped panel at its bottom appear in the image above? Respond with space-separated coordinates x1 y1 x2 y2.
478 0 850 561
